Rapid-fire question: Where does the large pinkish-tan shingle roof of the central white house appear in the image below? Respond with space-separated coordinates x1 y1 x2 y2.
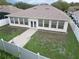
8 5 69 21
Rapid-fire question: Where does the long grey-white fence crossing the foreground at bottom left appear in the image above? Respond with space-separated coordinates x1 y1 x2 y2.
0 39 49 59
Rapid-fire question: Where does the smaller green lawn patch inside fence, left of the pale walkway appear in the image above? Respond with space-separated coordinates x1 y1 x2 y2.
0 25 26 41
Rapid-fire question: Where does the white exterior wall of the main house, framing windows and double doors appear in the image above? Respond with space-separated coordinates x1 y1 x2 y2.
9 19 68 32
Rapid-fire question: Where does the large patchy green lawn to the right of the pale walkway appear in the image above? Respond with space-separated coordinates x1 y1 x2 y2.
24 26 79 59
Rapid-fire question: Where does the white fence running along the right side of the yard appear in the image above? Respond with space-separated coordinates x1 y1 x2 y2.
69 19 79 42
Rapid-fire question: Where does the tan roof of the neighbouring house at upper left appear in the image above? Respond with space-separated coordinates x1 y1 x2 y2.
0 5 22 13
